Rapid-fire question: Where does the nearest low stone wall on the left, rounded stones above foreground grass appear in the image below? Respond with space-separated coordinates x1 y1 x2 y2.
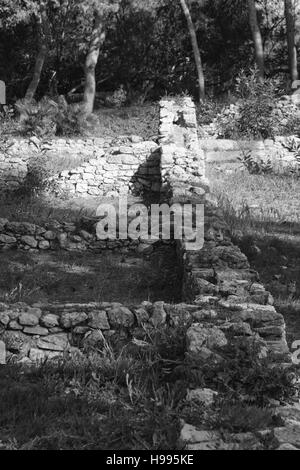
0 302 200 363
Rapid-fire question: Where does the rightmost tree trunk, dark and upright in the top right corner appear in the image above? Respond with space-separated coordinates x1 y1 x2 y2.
284 0 299 82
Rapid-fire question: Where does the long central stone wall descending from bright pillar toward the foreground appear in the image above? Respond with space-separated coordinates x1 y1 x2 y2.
160 99 288 355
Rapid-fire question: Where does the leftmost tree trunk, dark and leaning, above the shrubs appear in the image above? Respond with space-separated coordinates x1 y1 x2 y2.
25 2 50 101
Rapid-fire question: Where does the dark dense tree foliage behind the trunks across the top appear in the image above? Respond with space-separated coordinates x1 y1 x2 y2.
0 0 298 102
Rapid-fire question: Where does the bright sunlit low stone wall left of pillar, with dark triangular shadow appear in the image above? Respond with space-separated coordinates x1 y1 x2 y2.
0 136 160 196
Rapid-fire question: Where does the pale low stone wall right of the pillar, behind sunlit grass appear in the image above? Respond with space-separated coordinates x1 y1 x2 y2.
200 137 300 172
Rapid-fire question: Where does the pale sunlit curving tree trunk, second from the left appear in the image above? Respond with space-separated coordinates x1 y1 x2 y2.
83 11 105 115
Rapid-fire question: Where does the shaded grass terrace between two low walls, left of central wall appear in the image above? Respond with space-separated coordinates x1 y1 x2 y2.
0 246 181 304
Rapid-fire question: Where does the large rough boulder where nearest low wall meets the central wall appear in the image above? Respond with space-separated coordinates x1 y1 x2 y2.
187 323 228 353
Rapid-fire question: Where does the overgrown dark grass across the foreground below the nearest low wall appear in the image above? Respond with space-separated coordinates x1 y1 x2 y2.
0 325 293 450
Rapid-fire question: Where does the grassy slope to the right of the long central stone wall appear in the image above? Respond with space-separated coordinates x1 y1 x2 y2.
208 167 300 342
